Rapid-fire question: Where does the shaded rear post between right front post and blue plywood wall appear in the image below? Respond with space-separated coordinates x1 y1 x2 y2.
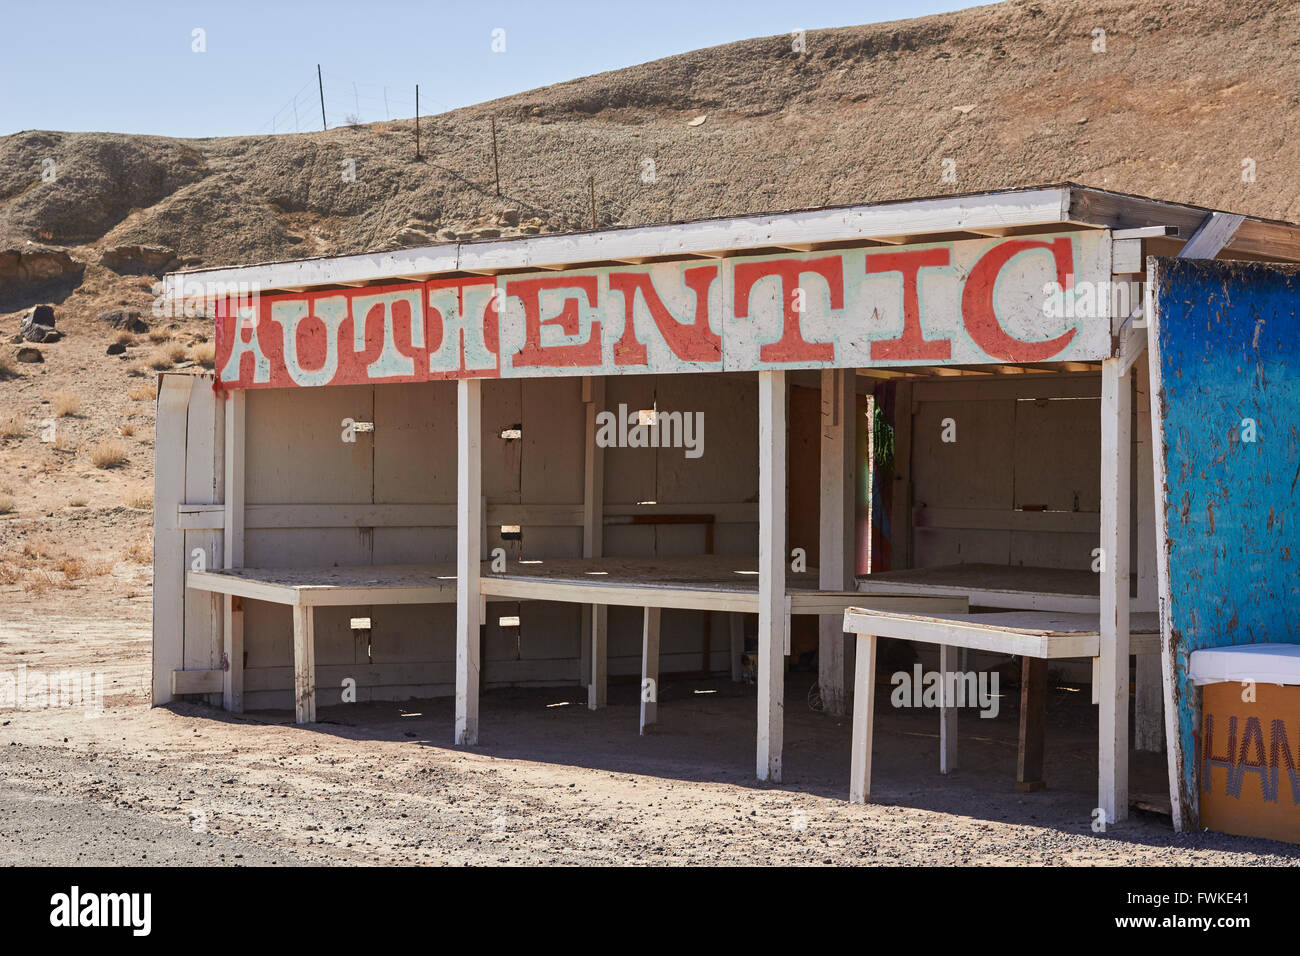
1134 351 1165 753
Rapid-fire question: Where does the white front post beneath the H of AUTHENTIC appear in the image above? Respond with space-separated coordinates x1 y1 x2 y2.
455 378 484 747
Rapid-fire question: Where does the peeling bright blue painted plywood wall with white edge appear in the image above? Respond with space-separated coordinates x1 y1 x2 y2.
1151 259 1300 829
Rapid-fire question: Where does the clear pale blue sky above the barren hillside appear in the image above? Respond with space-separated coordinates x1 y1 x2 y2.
0 0 979 137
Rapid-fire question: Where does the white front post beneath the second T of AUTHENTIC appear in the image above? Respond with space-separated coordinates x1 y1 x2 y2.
758 372 789 783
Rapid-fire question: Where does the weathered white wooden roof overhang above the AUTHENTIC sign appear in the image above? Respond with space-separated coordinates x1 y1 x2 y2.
164 183 1300 298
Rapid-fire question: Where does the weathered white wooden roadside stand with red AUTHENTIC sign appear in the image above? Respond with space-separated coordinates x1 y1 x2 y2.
153 183 1300 822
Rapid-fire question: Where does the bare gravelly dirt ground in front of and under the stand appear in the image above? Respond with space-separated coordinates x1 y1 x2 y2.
0 587 1300 866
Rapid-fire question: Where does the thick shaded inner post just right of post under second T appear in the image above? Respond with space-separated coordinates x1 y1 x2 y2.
818 368 858 714
